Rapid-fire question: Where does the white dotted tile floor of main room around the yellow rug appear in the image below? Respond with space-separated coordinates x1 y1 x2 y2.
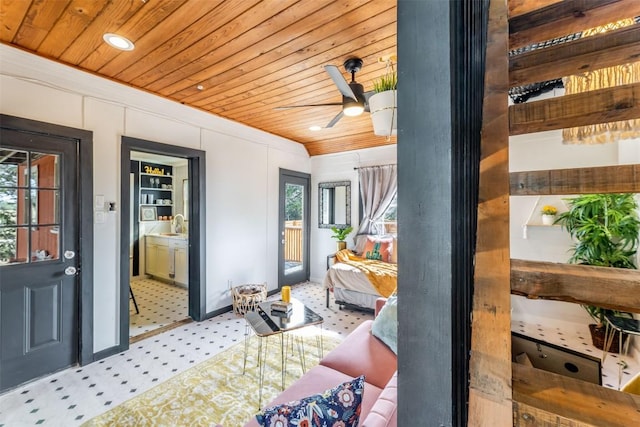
0 283 372 427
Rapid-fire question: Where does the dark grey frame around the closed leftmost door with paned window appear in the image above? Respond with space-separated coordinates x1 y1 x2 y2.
0 114 95 365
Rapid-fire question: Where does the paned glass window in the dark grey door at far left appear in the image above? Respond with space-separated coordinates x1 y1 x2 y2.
0 149 61 264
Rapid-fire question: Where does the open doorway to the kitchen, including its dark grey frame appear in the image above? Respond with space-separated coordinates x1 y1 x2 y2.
119 137 206 350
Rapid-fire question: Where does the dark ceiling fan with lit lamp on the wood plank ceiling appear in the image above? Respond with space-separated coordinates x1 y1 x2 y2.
276 58 374 128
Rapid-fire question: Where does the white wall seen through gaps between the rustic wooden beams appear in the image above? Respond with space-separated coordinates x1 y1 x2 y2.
509 131 640 323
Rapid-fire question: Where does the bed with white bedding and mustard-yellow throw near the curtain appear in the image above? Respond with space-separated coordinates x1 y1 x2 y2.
323 249 398 310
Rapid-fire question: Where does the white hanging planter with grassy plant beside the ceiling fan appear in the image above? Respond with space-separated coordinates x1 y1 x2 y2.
369 60 398 136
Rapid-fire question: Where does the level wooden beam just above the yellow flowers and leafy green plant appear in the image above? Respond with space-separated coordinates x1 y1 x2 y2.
510 165 640 196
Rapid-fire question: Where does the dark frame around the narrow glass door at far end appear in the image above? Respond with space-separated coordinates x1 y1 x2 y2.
278 168 311 290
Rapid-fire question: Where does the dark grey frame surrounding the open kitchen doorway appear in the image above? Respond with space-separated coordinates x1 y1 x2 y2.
116 136 207 352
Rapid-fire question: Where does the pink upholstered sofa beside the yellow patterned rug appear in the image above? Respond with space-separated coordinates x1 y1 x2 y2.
245 300 398 427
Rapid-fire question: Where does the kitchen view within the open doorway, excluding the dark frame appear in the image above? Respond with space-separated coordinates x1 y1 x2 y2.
129 151 189 342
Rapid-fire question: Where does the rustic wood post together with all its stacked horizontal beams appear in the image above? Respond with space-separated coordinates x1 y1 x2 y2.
480 0 640 427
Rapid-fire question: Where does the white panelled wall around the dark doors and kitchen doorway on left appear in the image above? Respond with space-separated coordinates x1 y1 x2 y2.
0 45 311 352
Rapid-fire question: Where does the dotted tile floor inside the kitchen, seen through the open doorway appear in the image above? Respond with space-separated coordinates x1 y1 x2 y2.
129 279 189 337
